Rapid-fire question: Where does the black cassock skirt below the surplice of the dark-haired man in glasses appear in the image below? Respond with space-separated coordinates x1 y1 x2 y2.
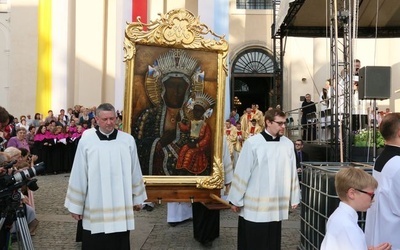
238 216 282 250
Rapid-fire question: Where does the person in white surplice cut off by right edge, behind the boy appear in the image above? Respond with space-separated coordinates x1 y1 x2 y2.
365 113 400 250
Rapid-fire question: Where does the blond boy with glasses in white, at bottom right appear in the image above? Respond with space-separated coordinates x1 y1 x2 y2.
321 167 392 250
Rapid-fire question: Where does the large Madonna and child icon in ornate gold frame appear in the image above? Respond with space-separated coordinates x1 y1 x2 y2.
123 9 228 201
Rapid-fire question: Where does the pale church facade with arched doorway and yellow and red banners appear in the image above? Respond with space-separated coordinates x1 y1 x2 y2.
0 0 400 119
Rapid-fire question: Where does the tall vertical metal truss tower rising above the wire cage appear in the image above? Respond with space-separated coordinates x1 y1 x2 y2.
330 0 359 162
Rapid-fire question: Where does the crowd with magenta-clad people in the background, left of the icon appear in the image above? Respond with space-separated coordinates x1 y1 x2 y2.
0 105 122 174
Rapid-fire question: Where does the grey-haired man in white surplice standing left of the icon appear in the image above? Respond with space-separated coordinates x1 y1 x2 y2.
64 103 147 250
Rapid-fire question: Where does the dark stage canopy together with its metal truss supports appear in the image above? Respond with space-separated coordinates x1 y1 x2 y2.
272 0 400 162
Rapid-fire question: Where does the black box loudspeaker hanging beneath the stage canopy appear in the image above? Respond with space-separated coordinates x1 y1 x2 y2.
358 66 390 99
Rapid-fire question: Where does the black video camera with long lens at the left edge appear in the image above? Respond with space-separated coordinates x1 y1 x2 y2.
0 161 45 212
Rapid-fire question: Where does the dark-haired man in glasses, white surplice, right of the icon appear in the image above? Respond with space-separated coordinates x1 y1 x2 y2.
228 109 300 249
